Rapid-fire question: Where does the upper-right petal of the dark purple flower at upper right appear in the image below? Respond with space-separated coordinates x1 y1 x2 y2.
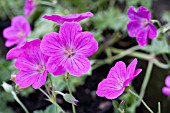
137 6 151 22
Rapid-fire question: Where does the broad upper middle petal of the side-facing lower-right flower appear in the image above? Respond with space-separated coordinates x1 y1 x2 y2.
107 61 128 82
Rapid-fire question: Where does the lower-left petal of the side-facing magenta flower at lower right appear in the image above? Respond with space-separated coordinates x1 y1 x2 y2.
96 78 125 99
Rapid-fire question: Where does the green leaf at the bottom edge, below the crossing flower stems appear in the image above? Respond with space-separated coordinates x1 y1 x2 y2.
33 104 61 113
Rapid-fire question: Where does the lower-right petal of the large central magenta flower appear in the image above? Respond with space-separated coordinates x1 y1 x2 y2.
66 56 90 76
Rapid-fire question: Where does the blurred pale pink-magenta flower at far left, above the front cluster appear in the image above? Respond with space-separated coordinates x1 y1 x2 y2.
3 16 31 47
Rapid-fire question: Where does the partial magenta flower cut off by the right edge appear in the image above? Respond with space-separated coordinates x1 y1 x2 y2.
162 75 170 96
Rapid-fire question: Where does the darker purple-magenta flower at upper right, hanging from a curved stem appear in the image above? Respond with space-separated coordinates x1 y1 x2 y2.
127 6 157 46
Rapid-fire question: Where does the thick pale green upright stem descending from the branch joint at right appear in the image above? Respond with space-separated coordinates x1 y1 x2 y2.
137 60 153 106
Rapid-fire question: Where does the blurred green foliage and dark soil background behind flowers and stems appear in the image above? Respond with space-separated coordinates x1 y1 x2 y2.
0 0 170 113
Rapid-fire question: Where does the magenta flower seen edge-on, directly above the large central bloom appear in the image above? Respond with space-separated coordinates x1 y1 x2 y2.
43 12 93 24
